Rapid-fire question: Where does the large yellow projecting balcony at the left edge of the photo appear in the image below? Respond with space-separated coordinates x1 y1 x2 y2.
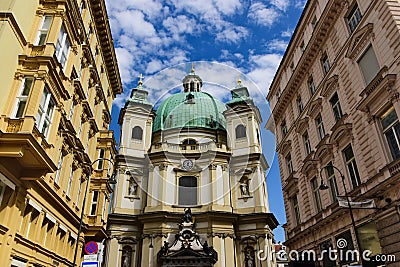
0 117 57 180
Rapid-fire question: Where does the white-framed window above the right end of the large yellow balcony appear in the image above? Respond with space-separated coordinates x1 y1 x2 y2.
35 86 55 137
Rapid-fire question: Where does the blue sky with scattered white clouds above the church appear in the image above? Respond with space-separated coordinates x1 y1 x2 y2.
106 0 306 241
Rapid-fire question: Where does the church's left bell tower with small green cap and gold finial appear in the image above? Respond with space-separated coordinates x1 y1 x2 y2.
113 75 154 214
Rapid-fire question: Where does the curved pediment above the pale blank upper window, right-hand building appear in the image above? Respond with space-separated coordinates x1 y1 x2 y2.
346 23 374 60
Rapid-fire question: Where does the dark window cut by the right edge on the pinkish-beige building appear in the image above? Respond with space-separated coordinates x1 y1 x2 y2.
381 107 400 160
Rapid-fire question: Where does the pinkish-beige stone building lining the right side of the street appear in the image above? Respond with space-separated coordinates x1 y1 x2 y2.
267 0 400 267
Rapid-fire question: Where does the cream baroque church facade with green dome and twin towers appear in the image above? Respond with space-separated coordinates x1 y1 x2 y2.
106 67 278 267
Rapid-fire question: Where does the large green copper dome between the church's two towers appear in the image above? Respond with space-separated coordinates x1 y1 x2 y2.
153 91 226 132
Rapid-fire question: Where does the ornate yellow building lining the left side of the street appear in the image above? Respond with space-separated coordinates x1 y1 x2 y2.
0 0 122 267
